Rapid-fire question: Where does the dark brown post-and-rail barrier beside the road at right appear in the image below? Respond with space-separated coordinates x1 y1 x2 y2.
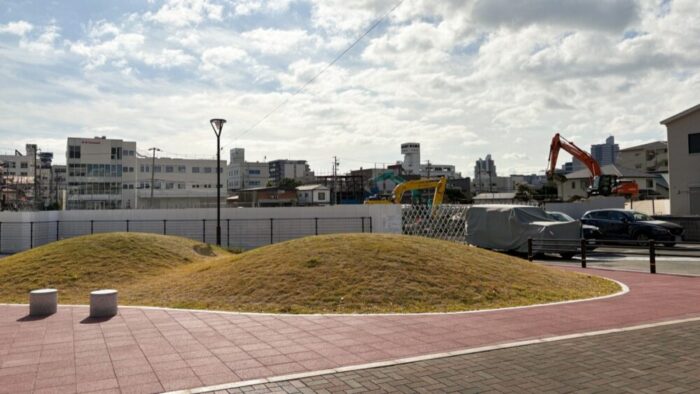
527 238 700 274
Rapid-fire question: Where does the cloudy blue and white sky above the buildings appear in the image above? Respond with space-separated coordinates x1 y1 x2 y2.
0 0 700 176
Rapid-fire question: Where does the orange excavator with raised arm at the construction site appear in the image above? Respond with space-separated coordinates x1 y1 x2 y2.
547 133 639 197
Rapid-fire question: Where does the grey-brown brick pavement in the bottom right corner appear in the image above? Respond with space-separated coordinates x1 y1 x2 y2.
219 322 700 394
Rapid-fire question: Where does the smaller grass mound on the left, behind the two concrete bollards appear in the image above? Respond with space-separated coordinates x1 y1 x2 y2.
0 233 229 304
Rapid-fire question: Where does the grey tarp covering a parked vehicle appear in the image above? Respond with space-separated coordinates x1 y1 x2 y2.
466 205 581 252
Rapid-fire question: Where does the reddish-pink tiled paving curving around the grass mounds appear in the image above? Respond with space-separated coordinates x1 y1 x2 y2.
0 269 700 393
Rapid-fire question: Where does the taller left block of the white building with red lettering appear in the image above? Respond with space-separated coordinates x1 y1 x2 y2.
66 137 138 209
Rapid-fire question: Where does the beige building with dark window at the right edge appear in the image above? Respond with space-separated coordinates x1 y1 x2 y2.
661 104 700 215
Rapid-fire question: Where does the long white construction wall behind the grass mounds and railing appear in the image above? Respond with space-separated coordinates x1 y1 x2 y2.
0 204 401 253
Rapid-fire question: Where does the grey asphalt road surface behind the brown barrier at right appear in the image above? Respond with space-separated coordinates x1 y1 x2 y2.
537 245 700 276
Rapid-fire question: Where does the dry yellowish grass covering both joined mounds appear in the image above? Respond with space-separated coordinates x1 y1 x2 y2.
0 233 619 313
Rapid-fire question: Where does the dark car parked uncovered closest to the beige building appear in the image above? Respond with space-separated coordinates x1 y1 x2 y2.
581 209 683 246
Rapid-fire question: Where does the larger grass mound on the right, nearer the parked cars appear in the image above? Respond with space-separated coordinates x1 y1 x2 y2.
125 234 619 313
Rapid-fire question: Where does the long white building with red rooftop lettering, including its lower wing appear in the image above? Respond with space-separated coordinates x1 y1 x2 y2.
66 137 226 209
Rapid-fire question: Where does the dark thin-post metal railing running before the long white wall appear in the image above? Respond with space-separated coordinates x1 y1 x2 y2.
0 216 373 253
